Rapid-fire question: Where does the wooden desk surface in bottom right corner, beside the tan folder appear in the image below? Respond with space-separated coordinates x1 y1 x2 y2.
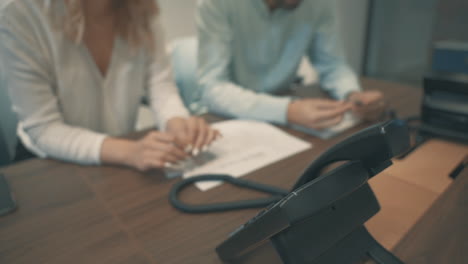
395 164 468 264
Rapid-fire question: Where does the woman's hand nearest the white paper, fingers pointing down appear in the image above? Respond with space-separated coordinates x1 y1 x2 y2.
166 117 221 156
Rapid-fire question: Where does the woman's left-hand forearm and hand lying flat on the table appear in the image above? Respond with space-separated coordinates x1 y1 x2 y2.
101 131 188 171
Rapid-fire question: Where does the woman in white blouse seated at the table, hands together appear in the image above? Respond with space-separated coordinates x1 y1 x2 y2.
0 0 217 170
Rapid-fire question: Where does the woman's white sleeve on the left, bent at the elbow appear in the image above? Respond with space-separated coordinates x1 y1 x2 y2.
0 4 106 164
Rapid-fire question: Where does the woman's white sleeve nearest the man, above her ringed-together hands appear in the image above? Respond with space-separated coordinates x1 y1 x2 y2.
147 19 190 130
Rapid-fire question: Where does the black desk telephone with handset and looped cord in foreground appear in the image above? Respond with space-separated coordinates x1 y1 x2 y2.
170 120 410 264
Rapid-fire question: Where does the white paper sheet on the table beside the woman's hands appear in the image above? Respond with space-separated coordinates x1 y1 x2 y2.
183 120 312 191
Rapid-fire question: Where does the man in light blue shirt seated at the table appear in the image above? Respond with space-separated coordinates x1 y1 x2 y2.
176 0 383 129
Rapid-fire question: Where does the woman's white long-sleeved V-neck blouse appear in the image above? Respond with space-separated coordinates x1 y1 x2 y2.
0 0 189 164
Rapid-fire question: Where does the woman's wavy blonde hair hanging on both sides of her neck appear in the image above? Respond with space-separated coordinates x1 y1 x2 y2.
48 0 159 52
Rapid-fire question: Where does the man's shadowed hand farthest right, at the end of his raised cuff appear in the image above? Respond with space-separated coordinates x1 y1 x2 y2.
348 91 386 121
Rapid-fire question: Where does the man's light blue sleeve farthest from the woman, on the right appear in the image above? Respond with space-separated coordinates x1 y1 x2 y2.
308 1 361 100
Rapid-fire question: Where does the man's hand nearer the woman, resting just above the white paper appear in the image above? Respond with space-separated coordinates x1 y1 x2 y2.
288 99 352 130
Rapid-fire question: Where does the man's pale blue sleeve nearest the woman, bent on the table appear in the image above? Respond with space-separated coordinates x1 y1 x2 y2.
197 0 290 124
